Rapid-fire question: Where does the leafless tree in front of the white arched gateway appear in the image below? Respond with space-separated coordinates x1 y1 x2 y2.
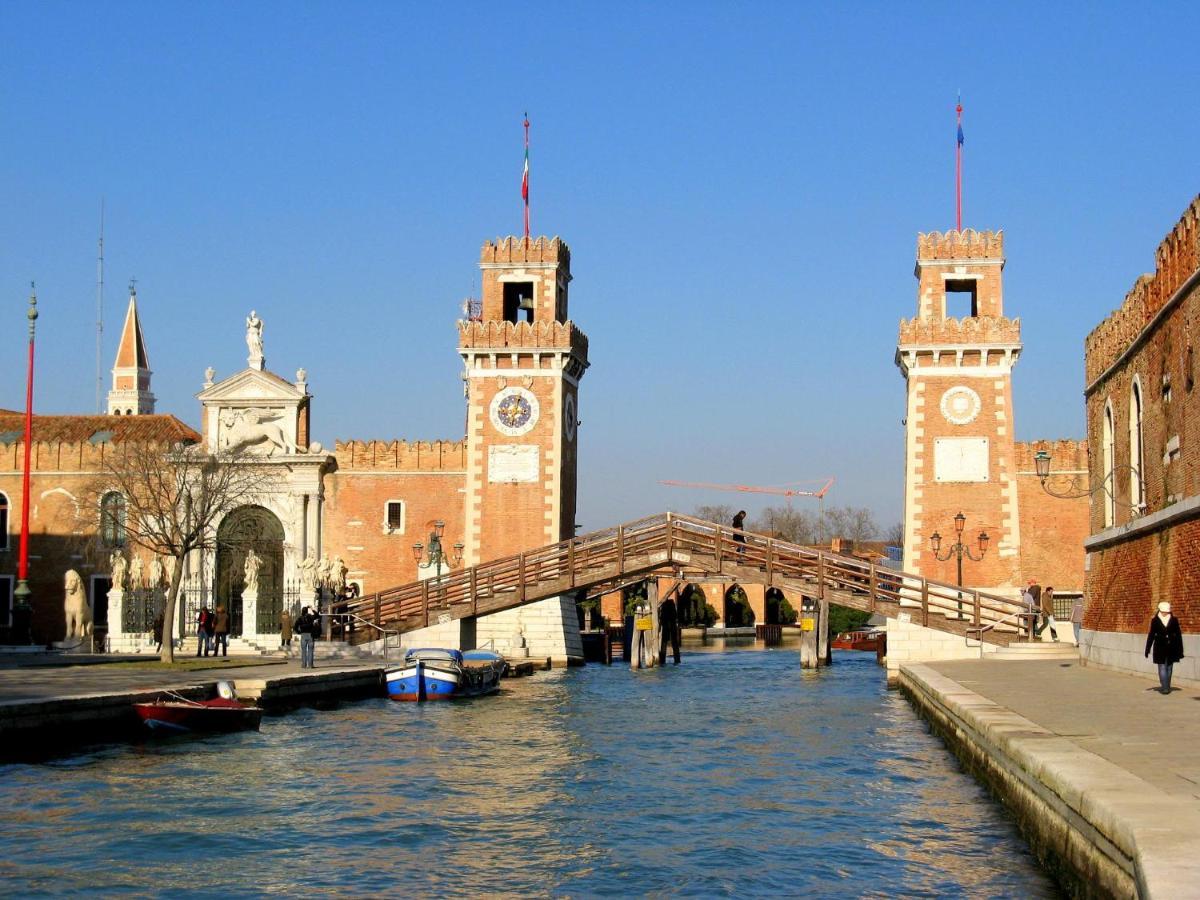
84 440 275 662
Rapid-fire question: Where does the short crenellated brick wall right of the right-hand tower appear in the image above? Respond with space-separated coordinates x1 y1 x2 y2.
1013 439 1090 593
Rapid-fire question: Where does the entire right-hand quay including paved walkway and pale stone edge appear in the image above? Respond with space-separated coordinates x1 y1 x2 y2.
900 660 1200 898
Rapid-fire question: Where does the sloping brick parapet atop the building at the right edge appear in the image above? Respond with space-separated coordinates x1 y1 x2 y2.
1084 196 1200 385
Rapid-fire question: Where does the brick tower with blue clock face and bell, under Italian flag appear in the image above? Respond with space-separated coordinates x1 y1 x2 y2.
458 238 588 565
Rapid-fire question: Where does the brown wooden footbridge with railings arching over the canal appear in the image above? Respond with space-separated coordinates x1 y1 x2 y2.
348 512 1025 646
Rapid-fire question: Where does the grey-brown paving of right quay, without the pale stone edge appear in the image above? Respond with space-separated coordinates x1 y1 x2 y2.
925 660 1200 800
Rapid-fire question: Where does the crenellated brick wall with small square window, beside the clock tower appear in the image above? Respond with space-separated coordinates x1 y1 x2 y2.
322 440 467 593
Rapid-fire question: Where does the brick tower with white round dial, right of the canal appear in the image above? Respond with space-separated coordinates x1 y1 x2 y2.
895 229 1021 590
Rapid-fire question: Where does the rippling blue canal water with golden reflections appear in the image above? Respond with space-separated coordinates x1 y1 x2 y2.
0 649 1057 898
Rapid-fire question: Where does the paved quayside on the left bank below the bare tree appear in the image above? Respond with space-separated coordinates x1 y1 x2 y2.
0 654 379 703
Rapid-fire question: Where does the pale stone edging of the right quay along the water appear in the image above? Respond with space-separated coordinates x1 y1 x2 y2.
900 665 1200 898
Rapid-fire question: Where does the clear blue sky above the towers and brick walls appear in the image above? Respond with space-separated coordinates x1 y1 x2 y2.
0 2 1200 528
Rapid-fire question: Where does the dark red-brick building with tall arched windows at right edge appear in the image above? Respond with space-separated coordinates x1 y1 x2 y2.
1080 197 1200 679
